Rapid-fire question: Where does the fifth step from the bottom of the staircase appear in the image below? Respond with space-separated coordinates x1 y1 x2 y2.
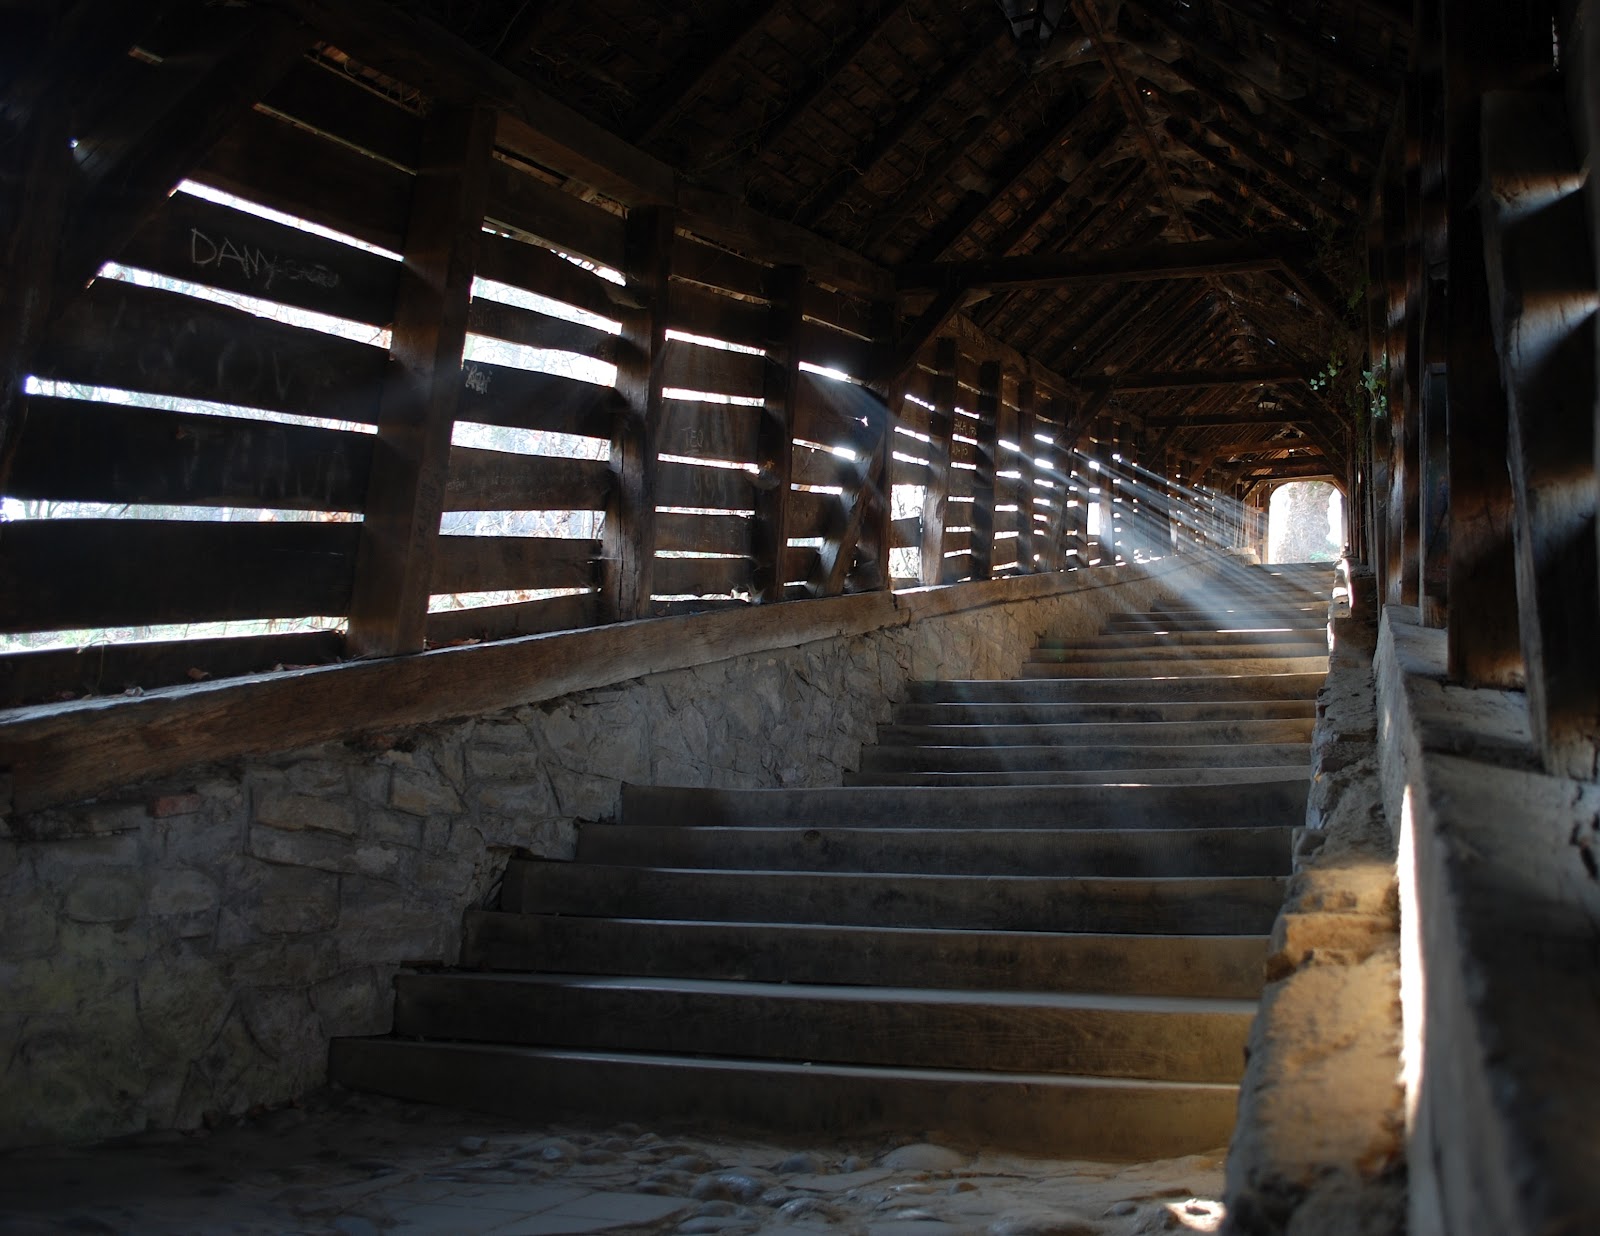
578 825 1293 879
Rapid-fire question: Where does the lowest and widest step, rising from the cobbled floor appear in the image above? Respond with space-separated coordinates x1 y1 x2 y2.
328 1039 1238 1159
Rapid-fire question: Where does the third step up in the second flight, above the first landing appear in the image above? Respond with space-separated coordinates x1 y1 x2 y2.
878 717 1315 749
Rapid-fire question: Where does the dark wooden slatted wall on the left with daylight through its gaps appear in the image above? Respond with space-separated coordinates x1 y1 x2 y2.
0 41 1184 706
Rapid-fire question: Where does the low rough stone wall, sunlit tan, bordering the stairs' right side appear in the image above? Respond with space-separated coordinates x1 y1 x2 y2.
1226 567 1406 1236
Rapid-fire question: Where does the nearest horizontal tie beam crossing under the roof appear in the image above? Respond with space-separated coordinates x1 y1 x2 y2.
894 235 1310 293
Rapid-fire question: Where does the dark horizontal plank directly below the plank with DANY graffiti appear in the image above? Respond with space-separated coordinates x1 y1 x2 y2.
34 279 389 424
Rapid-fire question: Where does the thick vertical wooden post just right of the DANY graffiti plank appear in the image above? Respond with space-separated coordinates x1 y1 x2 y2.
349 107 494 656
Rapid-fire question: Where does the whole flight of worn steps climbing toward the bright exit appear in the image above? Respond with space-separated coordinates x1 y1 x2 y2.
331 565 1331 1158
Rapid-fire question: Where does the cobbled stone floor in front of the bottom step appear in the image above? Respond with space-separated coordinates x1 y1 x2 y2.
0 1090 1222 1236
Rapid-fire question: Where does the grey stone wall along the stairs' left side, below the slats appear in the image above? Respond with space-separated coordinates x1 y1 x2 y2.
0 559 1200 1145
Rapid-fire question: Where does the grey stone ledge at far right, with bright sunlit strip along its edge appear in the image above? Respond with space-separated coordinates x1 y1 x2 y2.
1378 608 1600 1236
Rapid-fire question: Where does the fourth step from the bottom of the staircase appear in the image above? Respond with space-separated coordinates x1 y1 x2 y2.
501 860 1285 935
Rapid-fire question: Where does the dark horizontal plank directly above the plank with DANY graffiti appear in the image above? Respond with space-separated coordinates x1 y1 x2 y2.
189 112 413 253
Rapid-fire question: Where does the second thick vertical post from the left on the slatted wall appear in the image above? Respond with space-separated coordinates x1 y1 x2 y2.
602 207 674 623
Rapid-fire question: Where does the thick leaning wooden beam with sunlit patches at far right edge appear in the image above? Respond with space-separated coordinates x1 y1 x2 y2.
1483 91 1600 780
